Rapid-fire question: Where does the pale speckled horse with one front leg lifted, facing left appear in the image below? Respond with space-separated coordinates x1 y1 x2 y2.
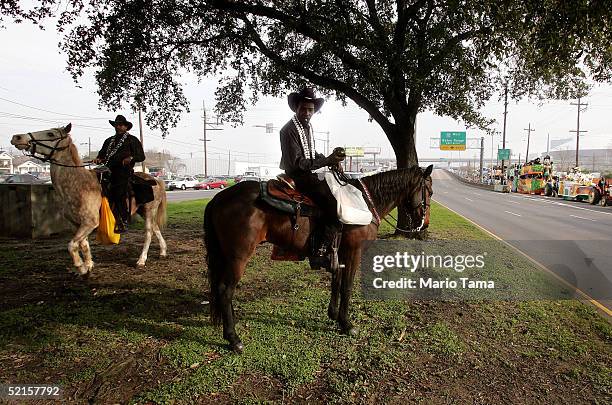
11 124 166 276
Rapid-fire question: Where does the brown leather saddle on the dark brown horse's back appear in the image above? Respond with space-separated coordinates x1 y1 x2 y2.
259 174 319 217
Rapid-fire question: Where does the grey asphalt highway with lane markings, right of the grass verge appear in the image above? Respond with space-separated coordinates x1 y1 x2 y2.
433 170 612 310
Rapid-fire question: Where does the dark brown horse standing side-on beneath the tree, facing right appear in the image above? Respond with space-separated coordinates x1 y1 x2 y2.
204 165 433 352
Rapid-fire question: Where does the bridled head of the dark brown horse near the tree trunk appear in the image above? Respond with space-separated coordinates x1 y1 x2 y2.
402 165 433 232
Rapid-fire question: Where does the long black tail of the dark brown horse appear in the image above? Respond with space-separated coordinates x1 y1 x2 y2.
204 198 224 325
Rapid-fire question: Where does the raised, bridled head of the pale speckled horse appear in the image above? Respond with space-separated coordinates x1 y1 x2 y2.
11 124 72 159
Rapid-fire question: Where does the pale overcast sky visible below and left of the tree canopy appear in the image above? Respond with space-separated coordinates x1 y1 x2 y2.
0 17 612 162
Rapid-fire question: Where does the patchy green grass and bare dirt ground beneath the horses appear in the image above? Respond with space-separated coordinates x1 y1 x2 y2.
0 200 612 403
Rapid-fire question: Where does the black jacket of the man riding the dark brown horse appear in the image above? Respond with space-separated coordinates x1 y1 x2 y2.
280 120 327 176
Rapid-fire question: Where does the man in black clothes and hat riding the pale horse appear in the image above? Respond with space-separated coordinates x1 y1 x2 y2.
93 115 145 233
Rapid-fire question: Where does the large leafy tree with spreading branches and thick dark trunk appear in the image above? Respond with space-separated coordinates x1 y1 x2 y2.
0 0 612 232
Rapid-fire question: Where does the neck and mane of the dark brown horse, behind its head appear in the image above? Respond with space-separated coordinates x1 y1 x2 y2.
351 166 421 207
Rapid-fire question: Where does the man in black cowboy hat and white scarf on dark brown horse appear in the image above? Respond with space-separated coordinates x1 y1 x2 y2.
280 87 344 269
